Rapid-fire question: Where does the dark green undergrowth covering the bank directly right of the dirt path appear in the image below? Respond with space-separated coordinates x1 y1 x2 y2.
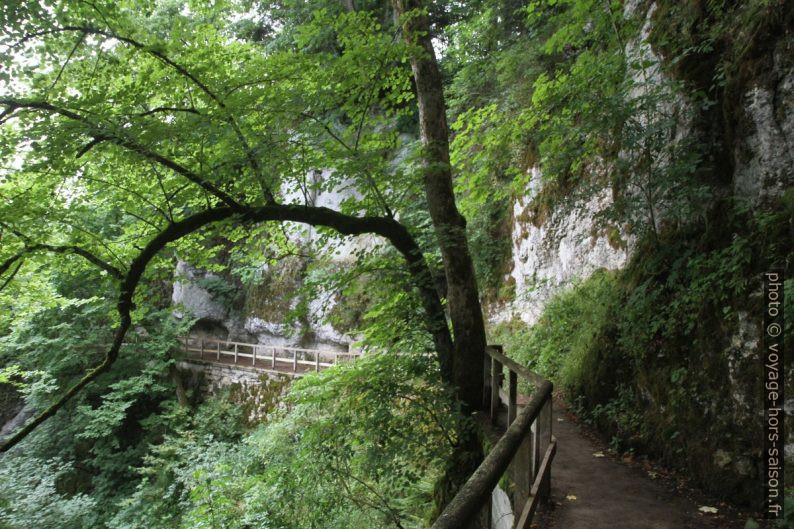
490 195 794 503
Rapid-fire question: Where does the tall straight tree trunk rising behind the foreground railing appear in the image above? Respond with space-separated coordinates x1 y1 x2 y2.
394 0 485 411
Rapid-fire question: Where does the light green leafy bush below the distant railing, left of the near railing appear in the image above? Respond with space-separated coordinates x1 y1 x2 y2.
163 354 466 529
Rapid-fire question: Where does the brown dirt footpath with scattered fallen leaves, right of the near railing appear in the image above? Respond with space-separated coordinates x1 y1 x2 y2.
533 399 744 529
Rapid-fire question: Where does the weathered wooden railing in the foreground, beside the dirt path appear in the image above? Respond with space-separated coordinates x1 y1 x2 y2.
431 346 557 529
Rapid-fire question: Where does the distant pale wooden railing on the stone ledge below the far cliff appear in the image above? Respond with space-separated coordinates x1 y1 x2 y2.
181 336 361 374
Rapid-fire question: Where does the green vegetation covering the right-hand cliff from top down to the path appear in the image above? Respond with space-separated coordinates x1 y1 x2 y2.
451 1 794 505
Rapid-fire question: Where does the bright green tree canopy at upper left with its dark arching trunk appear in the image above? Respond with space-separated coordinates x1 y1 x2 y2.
0 3 484 448
